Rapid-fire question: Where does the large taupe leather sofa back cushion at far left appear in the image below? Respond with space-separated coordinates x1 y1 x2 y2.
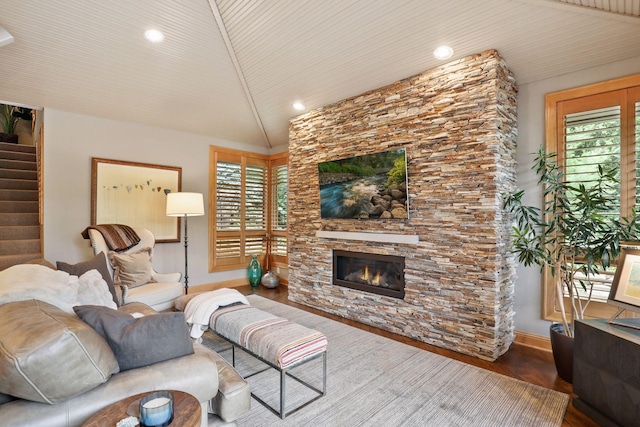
0 300 118 403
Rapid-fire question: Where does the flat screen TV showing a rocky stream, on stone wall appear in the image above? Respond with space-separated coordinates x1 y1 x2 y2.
318 148 409 220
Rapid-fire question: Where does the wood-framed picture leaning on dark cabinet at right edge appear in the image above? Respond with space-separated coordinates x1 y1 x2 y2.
608 248 640 311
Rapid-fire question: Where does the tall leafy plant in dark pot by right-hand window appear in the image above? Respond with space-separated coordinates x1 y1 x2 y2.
503 148 640 382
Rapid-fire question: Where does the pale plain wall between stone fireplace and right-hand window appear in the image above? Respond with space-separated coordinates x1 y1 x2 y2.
507 57 640 337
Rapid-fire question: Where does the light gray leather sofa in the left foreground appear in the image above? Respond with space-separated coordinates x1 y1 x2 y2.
0 266 251 427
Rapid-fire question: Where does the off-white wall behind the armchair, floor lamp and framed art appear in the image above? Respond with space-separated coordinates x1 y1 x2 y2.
44 109 268 285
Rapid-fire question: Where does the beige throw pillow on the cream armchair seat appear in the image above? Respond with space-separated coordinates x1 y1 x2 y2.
109 248 155 288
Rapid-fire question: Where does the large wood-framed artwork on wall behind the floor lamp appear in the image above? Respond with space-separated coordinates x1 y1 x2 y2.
91 157 182 243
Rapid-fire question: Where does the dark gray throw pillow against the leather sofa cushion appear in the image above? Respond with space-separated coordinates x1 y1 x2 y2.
73 305 193 371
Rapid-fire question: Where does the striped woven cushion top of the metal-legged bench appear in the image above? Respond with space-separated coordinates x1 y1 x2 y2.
209 304 327 369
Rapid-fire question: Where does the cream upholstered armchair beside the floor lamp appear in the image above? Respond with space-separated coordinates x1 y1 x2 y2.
88 228 184 311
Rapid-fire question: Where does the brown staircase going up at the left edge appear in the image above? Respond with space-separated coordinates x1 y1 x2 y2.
0 142 42 270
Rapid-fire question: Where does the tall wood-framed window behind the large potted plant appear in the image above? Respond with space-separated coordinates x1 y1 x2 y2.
544 75 640 319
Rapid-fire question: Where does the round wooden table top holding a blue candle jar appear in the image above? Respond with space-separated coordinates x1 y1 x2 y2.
82 390 202 427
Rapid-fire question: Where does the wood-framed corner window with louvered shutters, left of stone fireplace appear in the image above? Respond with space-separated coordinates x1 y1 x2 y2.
209 147 288 271
